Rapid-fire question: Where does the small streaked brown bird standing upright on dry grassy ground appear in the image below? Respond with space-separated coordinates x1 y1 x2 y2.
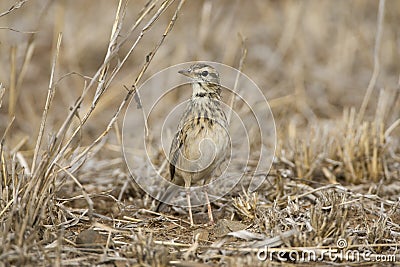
156 63 230 225
